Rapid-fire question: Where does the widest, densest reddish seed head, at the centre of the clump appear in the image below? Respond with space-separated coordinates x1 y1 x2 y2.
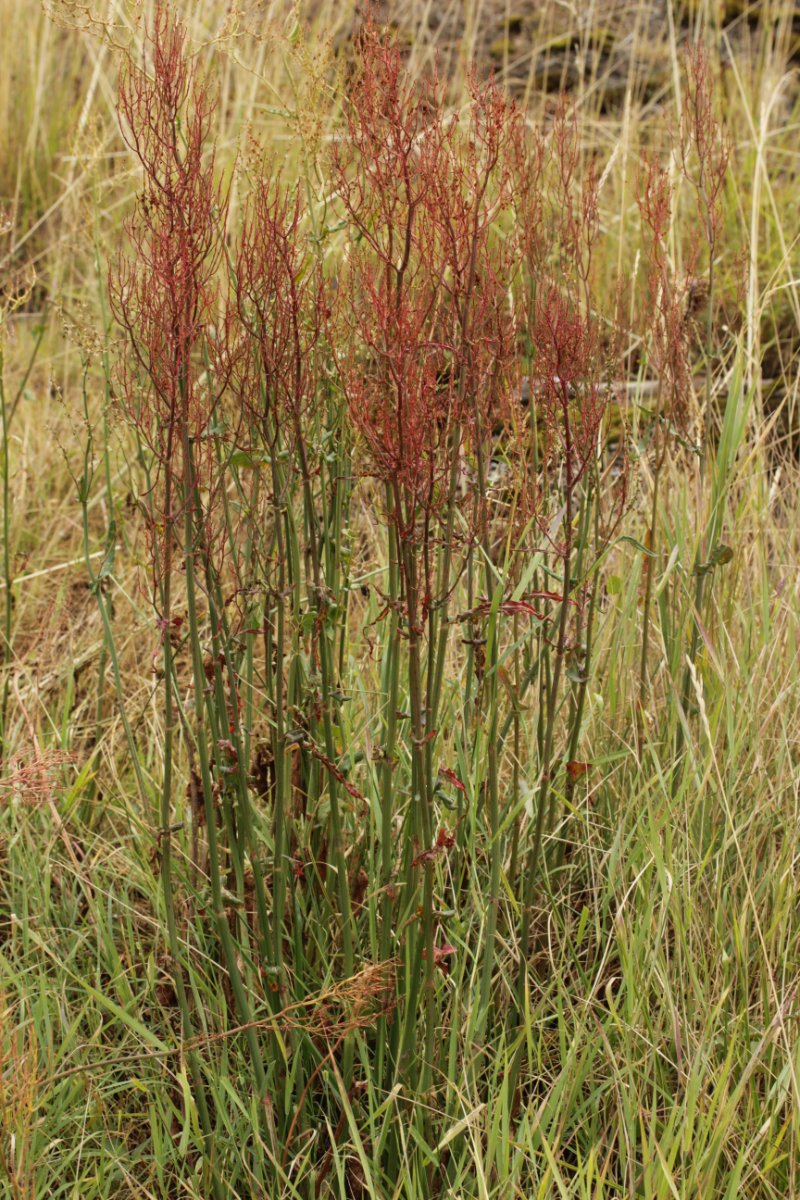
333 10 519 540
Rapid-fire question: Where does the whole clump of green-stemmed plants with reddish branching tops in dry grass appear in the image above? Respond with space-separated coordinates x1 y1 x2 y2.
100 6 743 1187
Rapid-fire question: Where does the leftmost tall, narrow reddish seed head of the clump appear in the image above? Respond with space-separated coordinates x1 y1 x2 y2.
109 5 229 590
